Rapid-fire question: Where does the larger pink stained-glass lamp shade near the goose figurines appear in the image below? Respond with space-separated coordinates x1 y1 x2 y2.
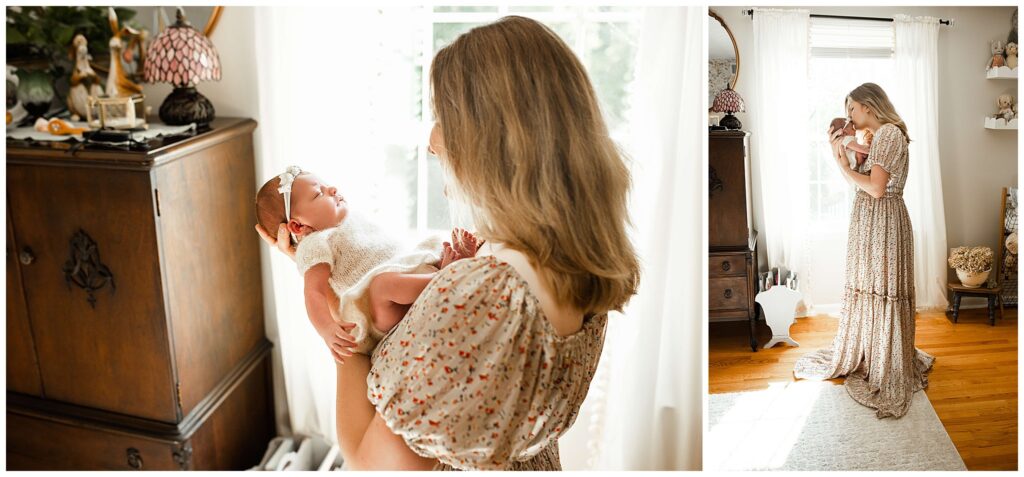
142 12 220 88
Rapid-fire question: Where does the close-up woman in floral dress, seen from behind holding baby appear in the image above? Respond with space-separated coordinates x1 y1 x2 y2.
261 16 639 470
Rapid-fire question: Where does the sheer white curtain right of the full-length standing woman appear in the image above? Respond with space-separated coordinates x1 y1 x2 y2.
892 15 947 309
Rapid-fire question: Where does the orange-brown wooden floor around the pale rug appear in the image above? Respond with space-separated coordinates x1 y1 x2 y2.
708 308 1017 470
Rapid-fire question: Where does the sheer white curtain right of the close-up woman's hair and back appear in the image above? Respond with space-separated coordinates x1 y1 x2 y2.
560 7 707 470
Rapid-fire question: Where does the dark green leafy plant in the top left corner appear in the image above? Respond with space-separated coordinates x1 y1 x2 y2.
7 6 135 78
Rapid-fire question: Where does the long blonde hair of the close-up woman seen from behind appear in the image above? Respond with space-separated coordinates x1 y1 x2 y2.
430 16 640 312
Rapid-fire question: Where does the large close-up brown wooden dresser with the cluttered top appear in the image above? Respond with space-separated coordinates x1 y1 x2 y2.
6 118 274 470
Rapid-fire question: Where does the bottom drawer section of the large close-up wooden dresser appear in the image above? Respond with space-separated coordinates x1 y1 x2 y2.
6 343 274 471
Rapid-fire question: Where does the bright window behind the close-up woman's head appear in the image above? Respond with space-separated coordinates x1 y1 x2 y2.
401 5 641 230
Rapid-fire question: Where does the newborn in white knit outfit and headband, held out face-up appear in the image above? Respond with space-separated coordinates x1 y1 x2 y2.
256 166 480 361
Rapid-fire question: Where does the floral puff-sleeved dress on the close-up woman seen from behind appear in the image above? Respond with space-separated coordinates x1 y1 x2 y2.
367 256 607 470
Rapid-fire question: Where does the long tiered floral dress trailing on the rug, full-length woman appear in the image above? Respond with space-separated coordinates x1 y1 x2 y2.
794 124 935 418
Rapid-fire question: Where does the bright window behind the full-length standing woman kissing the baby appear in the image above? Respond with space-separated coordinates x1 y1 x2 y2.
807 17 895 226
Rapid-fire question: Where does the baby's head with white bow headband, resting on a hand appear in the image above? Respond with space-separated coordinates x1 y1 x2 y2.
256 168 348 240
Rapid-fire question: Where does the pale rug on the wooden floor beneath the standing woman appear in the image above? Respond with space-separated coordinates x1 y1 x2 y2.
703 381 967 471
